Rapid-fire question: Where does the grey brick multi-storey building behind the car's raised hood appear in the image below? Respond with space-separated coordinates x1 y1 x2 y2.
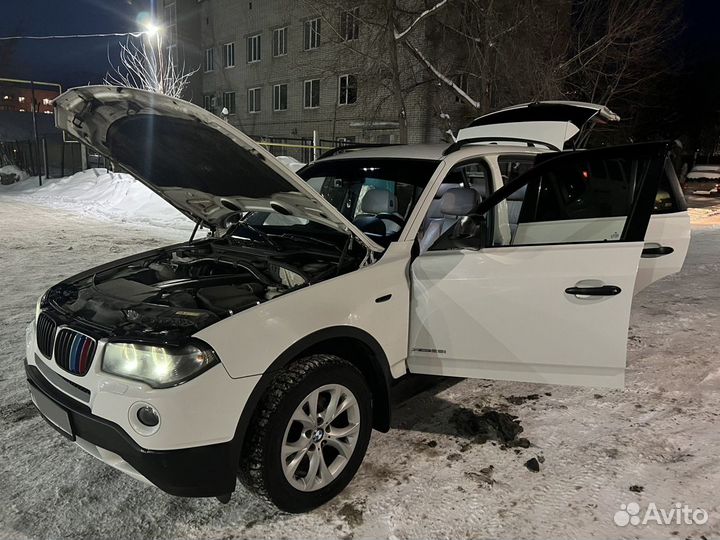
163 0 466 150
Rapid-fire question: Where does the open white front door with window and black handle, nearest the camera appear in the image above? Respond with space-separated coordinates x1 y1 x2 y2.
408 143 666 387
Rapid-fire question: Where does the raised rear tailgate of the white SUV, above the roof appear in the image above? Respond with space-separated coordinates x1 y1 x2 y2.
458 101 620 150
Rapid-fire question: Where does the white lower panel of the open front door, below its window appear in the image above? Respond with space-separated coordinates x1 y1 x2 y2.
408 242 643 387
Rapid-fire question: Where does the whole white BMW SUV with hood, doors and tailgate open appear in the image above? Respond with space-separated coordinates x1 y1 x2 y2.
26 87 690 512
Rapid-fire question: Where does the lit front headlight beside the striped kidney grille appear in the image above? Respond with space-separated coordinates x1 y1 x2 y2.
102 343 218 388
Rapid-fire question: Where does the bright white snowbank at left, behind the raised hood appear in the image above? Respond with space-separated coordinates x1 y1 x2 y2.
0 169 194 230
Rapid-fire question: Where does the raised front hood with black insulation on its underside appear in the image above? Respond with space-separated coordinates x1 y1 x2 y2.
55 86 383 252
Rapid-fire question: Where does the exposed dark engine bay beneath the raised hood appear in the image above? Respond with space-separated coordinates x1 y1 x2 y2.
45 237 364 343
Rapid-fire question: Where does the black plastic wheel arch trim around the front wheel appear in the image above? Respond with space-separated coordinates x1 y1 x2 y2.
234 326 392 464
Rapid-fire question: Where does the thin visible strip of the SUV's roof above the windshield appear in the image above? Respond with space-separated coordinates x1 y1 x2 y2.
318 143 548 161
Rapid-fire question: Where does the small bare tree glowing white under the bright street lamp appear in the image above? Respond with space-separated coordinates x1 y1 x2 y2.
104 31 199 98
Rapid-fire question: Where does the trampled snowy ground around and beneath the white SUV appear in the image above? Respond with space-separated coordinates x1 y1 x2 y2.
0 187 720 539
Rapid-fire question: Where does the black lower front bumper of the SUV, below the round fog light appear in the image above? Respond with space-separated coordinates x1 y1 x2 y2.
25 361 239 497
